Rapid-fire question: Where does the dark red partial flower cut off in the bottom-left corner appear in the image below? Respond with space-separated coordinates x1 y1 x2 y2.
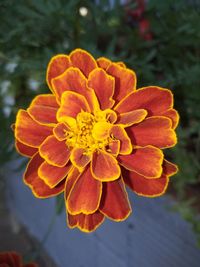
0 251 38 267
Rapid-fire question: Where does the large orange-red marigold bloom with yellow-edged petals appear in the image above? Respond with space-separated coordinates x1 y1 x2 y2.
15 49 179 232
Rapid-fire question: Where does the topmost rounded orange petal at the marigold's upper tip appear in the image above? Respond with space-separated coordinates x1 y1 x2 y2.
69 49 97 77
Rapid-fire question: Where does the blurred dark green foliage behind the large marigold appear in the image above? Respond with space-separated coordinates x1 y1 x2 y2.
0 0 200 245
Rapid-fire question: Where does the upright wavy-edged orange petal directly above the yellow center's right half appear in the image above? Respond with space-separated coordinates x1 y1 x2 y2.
88 68 115 110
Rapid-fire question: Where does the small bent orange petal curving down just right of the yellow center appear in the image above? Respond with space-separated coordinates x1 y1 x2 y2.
110 125 132 155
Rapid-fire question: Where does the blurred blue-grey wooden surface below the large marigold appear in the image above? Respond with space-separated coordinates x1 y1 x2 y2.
2 160 200 267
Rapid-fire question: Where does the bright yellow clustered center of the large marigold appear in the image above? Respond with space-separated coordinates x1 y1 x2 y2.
66 111 112 154
